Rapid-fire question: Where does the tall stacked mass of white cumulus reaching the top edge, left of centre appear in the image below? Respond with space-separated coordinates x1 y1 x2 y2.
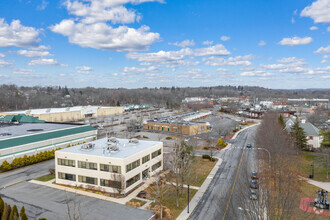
50 0 162 51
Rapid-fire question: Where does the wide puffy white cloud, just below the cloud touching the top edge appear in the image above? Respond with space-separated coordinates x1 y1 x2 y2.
51 20 160 51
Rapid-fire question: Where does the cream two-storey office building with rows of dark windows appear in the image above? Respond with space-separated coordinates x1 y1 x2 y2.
55 138 163 194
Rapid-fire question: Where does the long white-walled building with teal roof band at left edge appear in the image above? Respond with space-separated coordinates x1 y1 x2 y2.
0 123 97 164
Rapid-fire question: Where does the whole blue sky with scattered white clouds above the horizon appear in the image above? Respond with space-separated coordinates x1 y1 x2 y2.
0 0 330 89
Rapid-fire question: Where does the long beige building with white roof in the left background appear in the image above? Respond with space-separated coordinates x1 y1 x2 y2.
0 106 124 122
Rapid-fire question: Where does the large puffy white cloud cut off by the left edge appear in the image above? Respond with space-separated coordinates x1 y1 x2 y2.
0 18 40 48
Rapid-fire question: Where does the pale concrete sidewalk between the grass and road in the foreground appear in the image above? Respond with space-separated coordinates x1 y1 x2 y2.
177 158 222 220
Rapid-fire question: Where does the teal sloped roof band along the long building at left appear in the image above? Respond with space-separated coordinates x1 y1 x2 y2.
0 125 96 149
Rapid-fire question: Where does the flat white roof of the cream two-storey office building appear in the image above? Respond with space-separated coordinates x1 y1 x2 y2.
58 138 162 159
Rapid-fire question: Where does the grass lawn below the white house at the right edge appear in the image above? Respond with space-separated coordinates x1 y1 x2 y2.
299 154 330 182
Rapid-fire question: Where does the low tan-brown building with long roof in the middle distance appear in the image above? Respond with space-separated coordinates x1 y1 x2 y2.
143 111 211 135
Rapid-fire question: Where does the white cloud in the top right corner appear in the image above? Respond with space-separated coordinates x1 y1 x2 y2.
300 0 330 23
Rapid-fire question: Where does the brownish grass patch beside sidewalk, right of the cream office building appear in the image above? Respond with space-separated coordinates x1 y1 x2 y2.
185 156 218 186
